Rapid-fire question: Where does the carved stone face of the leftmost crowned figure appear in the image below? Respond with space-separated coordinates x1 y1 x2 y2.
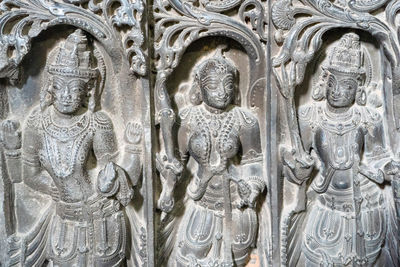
52 76 87 114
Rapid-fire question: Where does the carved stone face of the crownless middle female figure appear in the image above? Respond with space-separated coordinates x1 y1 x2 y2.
200 73 235 109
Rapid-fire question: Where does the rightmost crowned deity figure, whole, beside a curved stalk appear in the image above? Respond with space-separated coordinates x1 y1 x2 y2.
284 33 398 266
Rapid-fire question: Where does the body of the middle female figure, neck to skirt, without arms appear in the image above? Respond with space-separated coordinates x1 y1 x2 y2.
177 106 257 266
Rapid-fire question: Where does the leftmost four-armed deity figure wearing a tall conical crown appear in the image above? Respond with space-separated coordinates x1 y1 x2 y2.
3 30 140 266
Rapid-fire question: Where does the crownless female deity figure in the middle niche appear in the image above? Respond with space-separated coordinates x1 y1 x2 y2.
158 52 265 266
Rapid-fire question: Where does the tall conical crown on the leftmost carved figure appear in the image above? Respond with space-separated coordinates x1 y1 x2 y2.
48 30 98 78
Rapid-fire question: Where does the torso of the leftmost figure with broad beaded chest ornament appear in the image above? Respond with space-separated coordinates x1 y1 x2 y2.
27 108 115 202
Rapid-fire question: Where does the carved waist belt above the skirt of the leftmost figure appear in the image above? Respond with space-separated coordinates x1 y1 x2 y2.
56 196 119 222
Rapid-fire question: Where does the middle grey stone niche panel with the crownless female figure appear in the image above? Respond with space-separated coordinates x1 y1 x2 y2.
154 1 271 266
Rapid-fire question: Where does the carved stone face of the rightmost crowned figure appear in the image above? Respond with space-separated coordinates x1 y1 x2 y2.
326 73 358 108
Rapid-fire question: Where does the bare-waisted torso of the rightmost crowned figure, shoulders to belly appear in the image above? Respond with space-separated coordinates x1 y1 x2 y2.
299 102 381 193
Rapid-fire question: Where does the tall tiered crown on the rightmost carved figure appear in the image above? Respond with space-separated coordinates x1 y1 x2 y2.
324 33 365 75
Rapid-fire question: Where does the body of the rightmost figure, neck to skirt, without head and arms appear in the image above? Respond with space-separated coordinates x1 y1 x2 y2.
299 104 386 266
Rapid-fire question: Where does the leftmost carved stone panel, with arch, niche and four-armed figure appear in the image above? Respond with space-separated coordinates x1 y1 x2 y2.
0 0 154 266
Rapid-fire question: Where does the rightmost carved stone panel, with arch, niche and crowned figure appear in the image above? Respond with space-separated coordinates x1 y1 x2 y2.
271 1 399 266
